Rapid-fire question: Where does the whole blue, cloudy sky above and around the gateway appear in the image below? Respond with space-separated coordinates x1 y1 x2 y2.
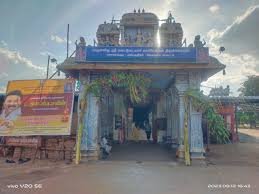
0 0 259 96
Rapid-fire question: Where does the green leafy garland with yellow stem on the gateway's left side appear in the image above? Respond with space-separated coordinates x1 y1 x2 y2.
75 72 151 164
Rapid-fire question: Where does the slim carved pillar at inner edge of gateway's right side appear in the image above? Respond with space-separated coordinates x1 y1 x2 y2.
175 73 188 158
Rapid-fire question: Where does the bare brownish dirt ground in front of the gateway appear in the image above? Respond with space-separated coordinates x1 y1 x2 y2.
0 143 259 194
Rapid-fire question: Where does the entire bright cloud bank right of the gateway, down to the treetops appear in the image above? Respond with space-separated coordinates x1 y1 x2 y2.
203 5 259 96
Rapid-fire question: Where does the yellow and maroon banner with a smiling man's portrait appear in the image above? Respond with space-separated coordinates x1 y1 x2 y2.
0 79 75 136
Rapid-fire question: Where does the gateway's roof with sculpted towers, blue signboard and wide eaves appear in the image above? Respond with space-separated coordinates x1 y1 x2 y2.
57 9 226 80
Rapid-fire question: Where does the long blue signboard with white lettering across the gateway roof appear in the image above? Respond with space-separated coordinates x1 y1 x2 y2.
76 46 208 63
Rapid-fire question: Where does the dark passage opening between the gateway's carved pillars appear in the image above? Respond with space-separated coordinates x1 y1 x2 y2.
108 77 178 161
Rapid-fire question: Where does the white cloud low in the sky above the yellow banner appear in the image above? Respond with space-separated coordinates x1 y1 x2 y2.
0 48 45 92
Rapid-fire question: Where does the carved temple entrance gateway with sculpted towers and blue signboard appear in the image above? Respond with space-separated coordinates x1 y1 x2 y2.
57 11 226 163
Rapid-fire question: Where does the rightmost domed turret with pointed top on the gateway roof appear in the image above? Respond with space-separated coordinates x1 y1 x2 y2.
159 12 183 47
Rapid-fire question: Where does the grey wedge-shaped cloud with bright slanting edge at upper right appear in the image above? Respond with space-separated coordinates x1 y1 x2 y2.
208 5 259 59
